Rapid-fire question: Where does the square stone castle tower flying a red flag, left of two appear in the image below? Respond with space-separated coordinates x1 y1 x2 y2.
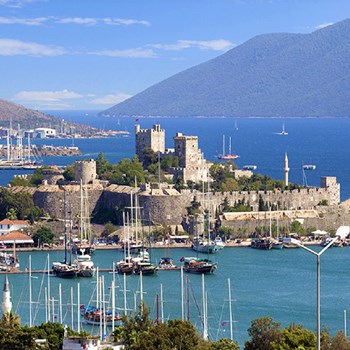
135 124 165 161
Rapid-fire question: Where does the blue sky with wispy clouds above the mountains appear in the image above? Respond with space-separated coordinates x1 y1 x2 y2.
0 0 350 111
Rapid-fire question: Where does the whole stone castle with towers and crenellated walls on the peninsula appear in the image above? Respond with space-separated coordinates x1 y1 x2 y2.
8 125 344 235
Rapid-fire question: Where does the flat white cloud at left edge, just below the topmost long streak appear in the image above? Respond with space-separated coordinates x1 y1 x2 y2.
0 39 66 56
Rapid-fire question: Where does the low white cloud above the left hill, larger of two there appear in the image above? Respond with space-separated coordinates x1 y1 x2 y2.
14 89 84 103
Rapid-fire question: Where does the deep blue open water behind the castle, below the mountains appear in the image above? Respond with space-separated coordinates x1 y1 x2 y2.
0 111 350 200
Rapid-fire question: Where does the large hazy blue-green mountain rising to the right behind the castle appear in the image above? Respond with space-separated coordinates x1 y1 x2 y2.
101 19 350 117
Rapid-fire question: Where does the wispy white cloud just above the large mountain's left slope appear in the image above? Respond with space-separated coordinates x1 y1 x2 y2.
151 39 235 51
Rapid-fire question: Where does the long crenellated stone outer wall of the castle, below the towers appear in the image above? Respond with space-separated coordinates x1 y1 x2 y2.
33 177 340 225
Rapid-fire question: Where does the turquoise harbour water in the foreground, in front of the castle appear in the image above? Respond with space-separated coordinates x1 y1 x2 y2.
9 247 350 345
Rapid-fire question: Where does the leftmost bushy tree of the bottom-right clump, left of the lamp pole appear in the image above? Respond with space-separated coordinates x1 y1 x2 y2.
244 317 282 350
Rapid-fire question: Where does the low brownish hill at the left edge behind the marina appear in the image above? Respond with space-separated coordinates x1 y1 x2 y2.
0 99 97 135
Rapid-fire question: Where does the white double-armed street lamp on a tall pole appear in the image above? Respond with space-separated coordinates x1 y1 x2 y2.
284 226 350 350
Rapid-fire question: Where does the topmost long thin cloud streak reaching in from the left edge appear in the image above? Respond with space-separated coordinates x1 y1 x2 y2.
0 15 151 26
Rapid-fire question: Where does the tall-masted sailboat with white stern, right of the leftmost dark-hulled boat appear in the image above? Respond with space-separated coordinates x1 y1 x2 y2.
74 180 95 277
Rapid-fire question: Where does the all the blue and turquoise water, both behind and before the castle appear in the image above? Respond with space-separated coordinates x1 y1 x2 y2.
0 111 350 346
